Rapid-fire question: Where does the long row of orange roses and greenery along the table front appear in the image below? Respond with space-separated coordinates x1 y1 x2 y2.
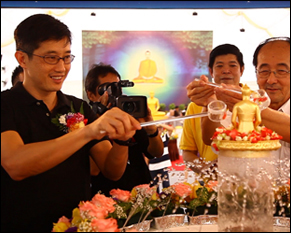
52 180 216 232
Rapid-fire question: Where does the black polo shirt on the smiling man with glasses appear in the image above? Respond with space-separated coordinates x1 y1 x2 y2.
1 83 98 232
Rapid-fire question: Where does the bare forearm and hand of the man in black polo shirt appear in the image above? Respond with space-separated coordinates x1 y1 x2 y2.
1 108 141 180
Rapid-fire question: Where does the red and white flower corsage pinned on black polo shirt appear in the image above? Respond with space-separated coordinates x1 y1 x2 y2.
52 102 88 133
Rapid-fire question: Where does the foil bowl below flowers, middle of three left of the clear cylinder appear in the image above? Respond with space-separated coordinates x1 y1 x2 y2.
153 214 186 230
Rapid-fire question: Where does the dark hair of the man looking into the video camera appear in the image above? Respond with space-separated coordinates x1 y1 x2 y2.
85 62 121 94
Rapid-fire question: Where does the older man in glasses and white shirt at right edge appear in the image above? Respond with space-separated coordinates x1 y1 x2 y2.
187 37 290 183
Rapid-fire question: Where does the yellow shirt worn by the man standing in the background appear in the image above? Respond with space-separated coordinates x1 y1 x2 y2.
180 102 217 161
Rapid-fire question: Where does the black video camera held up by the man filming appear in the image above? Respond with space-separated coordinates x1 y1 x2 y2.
92 80 147 118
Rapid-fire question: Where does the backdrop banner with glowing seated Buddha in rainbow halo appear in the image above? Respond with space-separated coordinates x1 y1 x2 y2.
82 31 213 106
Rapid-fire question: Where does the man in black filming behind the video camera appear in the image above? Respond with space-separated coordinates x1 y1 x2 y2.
85 63 164 196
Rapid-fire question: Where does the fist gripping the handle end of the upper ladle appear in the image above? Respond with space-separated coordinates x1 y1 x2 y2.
187 75 216 106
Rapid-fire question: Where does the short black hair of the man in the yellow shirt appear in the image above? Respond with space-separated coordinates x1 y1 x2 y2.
208 44 244 69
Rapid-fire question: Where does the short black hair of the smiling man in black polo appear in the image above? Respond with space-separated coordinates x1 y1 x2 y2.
14 14 72 57
